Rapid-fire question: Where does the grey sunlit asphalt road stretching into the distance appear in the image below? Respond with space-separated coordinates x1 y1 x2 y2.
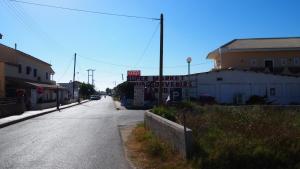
0 97 143 169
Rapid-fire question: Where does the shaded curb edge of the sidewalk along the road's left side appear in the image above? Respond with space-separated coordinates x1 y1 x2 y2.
0 100 88 129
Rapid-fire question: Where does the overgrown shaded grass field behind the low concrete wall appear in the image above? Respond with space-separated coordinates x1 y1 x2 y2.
152 103 300 169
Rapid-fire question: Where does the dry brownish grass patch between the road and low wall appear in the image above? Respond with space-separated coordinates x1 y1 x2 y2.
126 125 191 169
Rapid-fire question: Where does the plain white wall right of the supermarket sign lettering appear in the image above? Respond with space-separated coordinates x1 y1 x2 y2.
195 70 300 104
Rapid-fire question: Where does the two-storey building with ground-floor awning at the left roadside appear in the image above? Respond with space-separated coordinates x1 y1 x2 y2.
0 44 64 109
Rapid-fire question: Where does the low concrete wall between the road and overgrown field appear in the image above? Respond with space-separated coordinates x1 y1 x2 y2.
144 111 193 157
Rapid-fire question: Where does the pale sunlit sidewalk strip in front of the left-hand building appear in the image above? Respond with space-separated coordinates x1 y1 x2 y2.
0 100 88 128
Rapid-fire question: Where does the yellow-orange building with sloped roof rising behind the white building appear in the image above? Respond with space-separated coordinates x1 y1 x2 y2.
207 37 300 76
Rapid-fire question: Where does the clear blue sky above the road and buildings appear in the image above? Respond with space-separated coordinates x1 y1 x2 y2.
0 0 300 90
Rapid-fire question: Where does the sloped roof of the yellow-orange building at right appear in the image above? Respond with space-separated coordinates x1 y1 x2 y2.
207 37 300 58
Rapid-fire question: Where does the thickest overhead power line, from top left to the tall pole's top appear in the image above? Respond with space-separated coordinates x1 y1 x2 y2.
10 0 160 20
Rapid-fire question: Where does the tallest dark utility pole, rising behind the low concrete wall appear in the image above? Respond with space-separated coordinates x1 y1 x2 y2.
158 14 164 105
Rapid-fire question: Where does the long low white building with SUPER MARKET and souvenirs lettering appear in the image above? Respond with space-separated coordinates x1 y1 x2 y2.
128 69 300 105
